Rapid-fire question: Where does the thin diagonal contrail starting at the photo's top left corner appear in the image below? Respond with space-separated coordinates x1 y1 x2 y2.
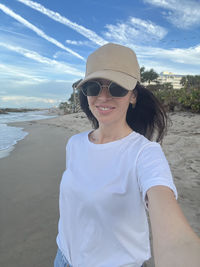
0 4 84 60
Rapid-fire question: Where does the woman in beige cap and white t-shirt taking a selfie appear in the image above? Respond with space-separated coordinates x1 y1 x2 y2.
54 43 200 267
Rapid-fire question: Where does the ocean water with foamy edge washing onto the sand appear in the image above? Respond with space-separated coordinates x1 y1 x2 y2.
0 111 56 158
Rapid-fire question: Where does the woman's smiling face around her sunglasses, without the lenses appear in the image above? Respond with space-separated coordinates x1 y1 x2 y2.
87 79 136 125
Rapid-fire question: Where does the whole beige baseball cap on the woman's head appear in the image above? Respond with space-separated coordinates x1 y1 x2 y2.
77 43 140 90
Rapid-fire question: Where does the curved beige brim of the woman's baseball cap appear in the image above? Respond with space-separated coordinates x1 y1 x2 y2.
76 70 138 91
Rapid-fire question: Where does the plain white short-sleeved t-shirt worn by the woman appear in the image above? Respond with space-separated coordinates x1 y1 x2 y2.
57 131 177 267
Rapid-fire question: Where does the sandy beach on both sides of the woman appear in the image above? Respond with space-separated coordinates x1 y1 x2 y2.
0 112 200 267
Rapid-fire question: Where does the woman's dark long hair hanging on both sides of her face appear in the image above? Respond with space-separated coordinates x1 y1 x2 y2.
79 83 168 142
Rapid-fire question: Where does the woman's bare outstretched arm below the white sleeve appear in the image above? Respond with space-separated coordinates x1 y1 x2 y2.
147 186 200 267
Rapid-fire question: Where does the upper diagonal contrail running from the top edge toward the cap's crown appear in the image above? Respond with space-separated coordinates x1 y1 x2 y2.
17 0 107 45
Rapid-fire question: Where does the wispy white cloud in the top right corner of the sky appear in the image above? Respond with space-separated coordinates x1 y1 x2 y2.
143 0 200 29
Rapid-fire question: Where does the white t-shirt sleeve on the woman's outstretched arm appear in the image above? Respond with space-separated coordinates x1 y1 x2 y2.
136 142 178 208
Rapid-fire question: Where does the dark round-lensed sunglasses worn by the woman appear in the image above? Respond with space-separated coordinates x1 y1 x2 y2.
81 81 128 97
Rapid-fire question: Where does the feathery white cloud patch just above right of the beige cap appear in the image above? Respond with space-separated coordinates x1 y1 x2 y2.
104 17 167 44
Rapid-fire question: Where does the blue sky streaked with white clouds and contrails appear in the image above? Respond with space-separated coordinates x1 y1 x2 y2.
0 0 200 107
